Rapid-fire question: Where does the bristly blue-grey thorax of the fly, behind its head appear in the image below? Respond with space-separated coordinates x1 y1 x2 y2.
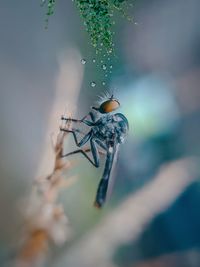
93 114 127 146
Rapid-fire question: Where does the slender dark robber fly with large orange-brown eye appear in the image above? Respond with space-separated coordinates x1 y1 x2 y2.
60 95 129 208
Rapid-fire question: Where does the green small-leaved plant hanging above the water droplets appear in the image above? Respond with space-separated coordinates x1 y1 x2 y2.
42 0 130 54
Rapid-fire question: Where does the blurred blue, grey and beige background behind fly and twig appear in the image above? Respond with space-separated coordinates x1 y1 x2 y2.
0 0 200 267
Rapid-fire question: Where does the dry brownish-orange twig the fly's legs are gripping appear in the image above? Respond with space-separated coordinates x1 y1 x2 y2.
16 119 74 267
